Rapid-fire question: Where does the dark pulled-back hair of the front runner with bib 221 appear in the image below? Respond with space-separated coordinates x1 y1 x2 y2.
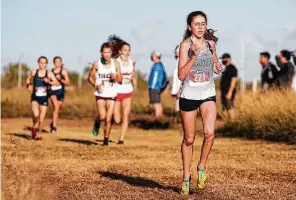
183 11 218 42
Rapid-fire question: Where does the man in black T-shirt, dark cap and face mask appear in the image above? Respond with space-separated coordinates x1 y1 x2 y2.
220 53 237 121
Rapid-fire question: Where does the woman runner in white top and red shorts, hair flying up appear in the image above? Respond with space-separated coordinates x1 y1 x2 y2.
109 36 136 144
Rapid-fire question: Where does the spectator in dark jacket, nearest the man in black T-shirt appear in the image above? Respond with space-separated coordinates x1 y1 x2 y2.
259 51 278 90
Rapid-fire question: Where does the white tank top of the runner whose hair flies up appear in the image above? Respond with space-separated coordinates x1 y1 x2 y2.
117 58 134 93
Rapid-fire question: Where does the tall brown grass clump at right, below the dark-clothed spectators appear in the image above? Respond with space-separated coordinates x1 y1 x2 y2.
221 91 296 144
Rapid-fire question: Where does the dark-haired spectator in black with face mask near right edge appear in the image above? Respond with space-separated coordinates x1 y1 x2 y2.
275 50 295 88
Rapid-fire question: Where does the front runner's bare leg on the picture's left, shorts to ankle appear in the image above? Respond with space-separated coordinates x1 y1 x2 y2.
181 110 197 179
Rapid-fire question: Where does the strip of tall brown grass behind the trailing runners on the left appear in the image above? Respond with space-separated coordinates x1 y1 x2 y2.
1 87 175 119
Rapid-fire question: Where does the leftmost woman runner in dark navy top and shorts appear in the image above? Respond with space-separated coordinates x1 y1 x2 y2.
26 56 59 140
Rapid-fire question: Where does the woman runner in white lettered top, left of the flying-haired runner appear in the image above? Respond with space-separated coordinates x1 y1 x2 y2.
88 43 122 146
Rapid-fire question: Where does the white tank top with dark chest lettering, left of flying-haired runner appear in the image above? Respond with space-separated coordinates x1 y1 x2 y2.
94 59 117 98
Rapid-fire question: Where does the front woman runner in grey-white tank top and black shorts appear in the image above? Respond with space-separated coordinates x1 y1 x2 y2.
178 11 223 195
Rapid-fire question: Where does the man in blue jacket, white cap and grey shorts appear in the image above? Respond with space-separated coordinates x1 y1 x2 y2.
148 51 166 118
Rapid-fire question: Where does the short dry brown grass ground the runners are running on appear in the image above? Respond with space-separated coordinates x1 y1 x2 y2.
1 119 296 200
